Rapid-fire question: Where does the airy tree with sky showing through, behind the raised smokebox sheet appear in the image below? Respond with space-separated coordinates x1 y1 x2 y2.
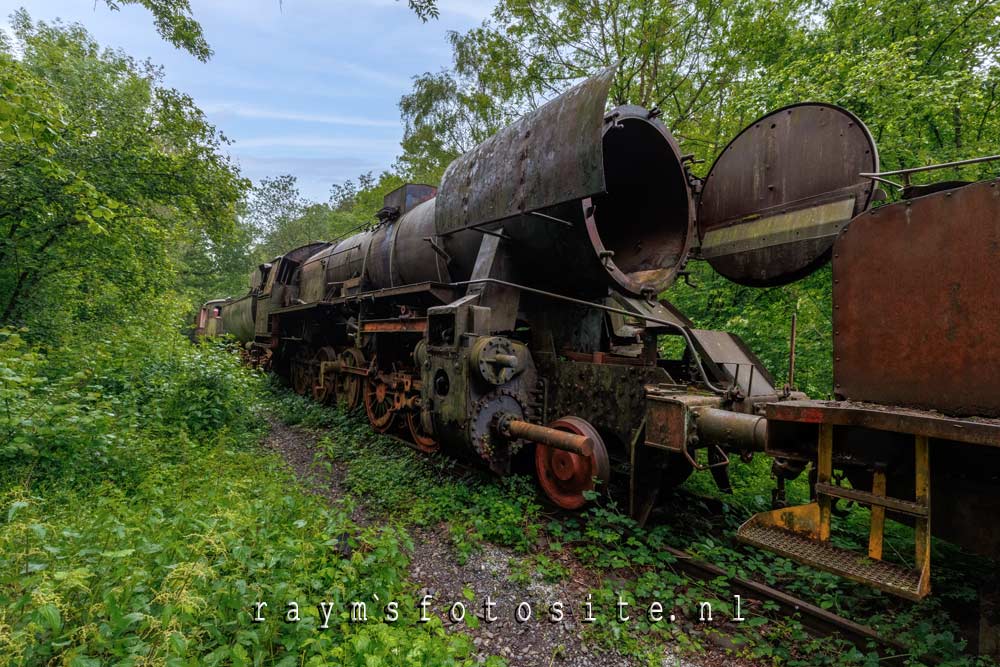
399 0 813 180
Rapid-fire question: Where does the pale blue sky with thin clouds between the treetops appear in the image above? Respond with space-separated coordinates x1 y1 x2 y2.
0 0 493 201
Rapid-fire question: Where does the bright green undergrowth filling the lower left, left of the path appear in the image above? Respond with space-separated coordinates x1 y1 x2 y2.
0 326 495 667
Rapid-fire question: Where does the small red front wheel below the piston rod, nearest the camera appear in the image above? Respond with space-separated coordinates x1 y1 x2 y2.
535 417 611 510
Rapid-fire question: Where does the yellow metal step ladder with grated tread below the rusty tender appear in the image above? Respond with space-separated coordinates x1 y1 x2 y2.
737 424 931 600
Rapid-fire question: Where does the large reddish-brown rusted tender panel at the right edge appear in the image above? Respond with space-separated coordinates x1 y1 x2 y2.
833 180 1000 417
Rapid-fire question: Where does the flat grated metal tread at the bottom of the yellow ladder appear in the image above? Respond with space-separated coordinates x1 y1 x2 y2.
738 521 926 600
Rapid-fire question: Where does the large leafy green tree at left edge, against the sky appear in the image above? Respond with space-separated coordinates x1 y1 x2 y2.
0 12 246 335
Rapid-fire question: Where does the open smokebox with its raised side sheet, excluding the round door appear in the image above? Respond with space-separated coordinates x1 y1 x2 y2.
436 68 695 297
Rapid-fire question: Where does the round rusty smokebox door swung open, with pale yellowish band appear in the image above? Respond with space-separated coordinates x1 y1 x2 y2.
698 104 878 286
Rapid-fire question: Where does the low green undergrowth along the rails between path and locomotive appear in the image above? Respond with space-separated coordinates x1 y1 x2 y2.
275 391 992 666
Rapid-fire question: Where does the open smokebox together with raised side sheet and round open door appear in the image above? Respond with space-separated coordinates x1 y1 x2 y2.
435 68 878 297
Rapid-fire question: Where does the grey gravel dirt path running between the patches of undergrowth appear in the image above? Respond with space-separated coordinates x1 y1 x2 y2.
265 421 749 667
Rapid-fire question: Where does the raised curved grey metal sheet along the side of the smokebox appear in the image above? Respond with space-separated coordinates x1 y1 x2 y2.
436 67 615 234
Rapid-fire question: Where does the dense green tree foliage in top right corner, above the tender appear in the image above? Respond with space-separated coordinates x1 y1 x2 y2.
746 0 1000 178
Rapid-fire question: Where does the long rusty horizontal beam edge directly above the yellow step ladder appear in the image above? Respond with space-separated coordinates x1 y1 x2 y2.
766 401 1000 447
